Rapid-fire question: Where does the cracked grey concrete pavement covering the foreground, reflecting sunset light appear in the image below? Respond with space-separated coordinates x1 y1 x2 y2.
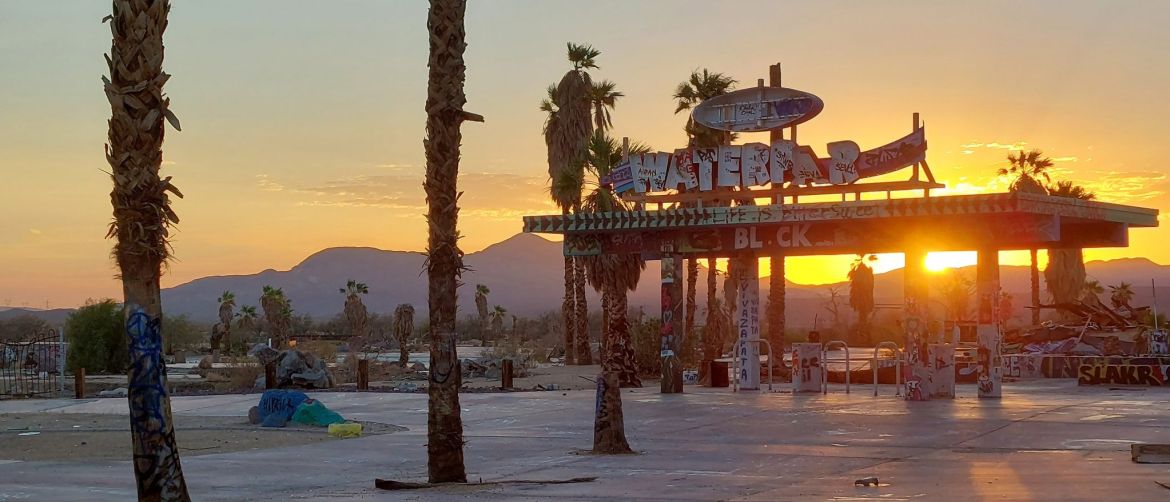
0 380 1170 501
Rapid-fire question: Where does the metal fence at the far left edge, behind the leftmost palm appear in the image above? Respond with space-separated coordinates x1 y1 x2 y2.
0 330 64 399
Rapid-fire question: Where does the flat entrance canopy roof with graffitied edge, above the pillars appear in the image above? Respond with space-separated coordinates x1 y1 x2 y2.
524 192 1158 259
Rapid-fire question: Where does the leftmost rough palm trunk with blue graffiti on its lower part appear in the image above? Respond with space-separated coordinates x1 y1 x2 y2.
102 0 191 493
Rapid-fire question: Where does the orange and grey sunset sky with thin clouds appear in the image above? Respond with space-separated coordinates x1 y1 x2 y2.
0 0 1170 308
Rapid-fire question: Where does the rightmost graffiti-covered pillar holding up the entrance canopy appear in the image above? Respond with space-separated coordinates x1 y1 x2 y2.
975 249 1004 398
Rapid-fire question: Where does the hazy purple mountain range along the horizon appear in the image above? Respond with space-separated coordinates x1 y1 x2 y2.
0 234 1170 328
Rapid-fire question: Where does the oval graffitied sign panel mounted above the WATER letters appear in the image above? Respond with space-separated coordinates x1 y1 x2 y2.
690 87 825 132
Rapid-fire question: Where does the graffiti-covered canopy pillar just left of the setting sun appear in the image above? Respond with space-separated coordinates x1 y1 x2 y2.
902 249 934 401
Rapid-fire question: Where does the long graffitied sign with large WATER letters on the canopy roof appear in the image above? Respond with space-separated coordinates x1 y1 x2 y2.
601 128 927 193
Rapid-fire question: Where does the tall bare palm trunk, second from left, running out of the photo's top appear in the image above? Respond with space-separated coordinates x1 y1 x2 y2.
422 0 476 483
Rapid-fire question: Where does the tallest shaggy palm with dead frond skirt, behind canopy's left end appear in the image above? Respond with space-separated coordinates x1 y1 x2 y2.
541 42 601 364
